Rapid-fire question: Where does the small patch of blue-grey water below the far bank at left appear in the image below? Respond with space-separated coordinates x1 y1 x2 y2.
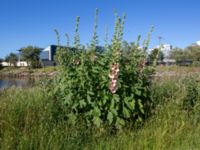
0 78 32 89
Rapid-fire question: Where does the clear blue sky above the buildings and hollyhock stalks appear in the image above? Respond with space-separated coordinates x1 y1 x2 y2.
0 0 200 58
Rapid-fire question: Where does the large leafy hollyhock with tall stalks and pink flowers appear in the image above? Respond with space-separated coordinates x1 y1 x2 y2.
50 10 158 129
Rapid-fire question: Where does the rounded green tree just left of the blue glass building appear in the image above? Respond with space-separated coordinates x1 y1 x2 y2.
21 46 41 68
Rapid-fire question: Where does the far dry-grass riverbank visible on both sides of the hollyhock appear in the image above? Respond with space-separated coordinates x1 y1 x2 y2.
0 65 200 78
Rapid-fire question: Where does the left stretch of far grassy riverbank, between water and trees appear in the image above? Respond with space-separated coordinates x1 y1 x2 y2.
0 67 57 78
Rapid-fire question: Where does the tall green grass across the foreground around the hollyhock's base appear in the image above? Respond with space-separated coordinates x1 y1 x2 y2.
0 75 200 150
